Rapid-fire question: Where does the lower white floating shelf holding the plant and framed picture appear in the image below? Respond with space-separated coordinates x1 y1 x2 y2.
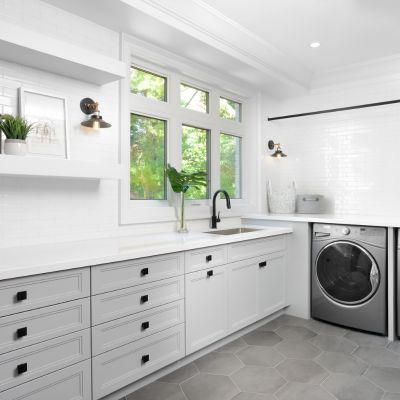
0 154 122 180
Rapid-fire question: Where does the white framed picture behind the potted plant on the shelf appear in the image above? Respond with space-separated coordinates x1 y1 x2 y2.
19 88 69 159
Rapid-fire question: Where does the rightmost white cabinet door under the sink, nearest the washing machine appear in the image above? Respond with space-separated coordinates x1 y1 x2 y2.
258 252 287 318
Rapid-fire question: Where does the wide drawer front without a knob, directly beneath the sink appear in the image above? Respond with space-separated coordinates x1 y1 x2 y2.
228 236 286 262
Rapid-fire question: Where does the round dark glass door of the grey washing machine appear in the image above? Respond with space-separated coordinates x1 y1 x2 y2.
316 241 380 306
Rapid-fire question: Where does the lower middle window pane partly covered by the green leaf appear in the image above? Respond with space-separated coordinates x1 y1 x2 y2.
182 125 210 199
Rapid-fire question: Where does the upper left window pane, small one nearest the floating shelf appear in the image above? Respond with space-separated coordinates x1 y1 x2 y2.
131 67 167 101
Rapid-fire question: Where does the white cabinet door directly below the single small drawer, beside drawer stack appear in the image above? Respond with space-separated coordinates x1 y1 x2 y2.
185 266 228 354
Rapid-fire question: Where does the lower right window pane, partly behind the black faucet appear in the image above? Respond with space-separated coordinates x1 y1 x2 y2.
220 133 242 199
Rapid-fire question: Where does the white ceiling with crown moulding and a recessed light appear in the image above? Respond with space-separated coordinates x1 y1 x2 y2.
41 0 400 95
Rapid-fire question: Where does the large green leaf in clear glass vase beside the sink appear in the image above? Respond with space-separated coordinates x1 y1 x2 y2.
165 164 207 233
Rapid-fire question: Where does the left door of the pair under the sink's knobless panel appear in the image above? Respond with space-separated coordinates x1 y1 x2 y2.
228 258 259 333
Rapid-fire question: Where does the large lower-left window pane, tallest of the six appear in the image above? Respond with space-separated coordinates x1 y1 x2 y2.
130 114 167 200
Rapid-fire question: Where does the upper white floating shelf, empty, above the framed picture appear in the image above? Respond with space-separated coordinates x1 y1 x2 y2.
0 21 126 85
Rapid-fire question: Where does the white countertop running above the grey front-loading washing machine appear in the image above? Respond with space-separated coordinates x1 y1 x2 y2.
242 214 400 228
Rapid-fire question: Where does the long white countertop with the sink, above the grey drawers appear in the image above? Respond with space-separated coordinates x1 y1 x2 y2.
0 225 292 280
